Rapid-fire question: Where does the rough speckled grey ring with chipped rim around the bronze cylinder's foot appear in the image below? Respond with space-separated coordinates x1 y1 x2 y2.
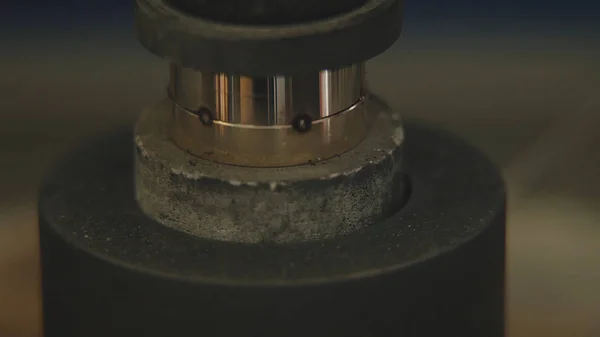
135 94 404 243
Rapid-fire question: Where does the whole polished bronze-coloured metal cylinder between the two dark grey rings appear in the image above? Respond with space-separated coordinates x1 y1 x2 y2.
169 63 375 167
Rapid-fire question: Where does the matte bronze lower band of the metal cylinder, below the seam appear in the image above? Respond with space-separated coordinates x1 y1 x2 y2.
165 97 372 167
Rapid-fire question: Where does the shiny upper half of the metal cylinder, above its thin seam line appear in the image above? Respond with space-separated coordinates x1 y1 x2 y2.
169 64 365 125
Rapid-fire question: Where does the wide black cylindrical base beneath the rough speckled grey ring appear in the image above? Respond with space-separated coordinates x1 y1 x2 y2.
40 125 505 337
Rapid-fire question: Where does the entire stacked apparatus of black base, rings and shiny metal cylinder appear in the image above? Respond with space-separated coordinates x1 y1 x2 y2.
39 0 505 337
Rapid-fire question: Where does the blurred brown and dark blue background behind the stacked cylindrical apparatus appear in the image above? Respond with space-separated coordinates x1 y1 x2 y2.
0 0 600 337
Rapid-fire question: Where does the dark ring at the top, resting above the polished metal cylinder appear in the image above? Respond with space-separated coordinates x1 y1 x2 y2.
135 0 403 76
